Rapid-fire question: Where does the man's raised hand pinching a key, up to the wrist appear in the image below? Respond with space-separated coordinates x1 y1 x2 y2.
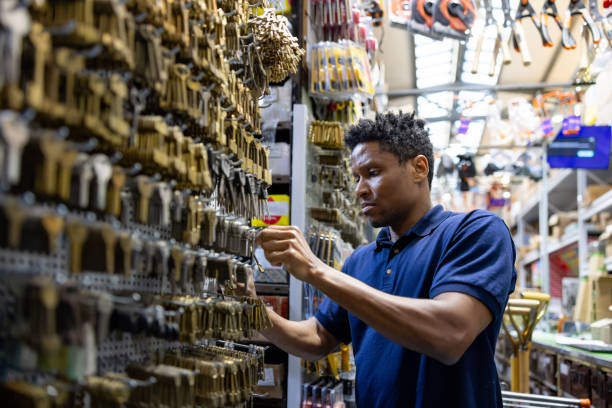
255 226 327 283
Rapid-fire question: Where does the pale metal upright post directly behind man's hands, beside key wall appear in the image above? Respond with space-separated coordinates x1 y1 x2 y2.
287 104 308 408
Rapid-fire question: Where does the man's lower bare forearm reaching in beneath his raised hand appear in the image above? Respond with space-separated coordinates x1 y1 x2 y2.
260 309 335 360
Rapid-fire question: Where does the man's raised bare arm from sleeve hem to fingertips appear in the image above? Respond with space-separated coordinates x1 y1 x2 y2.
257 227 500 364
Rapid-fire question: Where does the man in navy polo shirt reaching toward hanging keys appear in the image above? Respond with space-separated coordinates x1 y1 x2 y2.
251 113 516 408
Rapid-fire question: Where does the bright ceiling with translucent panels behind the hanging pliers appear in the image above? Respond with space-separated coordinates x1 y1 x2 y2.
378 0 606 149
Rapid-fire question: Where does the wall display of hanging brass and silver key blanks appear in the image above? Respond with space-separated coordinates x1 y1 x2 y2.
0 0 303 407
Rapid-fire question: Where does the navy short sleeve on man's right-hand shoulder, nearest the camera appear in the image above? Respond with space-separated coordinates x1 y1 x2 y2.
429 211 516 319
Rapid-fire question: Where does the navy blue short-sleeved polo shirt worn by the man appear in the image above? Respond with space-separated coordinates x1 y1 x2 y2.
316 206 516 408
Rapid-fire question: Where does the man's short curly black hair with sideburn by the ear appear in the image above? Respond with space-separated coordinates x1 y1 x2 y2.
344 111 434 188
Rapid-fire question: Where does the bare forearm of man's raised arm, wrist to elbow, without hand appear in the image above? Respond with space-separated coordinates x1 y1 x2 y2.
310 268 486 364
